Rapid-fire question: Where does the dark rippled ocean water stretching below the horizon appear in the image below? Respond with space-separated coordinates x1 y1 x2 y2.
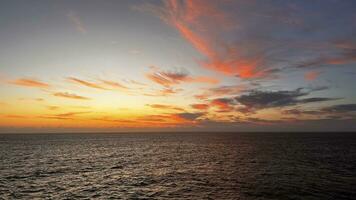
0 133 356 199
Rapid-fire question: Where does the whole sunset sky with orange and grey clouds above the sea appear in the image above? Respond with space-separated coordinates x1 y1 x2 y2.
0 0 356 133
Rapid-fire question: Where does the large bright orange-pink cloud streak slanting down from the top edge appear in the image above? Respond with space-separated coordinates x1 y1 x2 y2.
159 0 266 78
